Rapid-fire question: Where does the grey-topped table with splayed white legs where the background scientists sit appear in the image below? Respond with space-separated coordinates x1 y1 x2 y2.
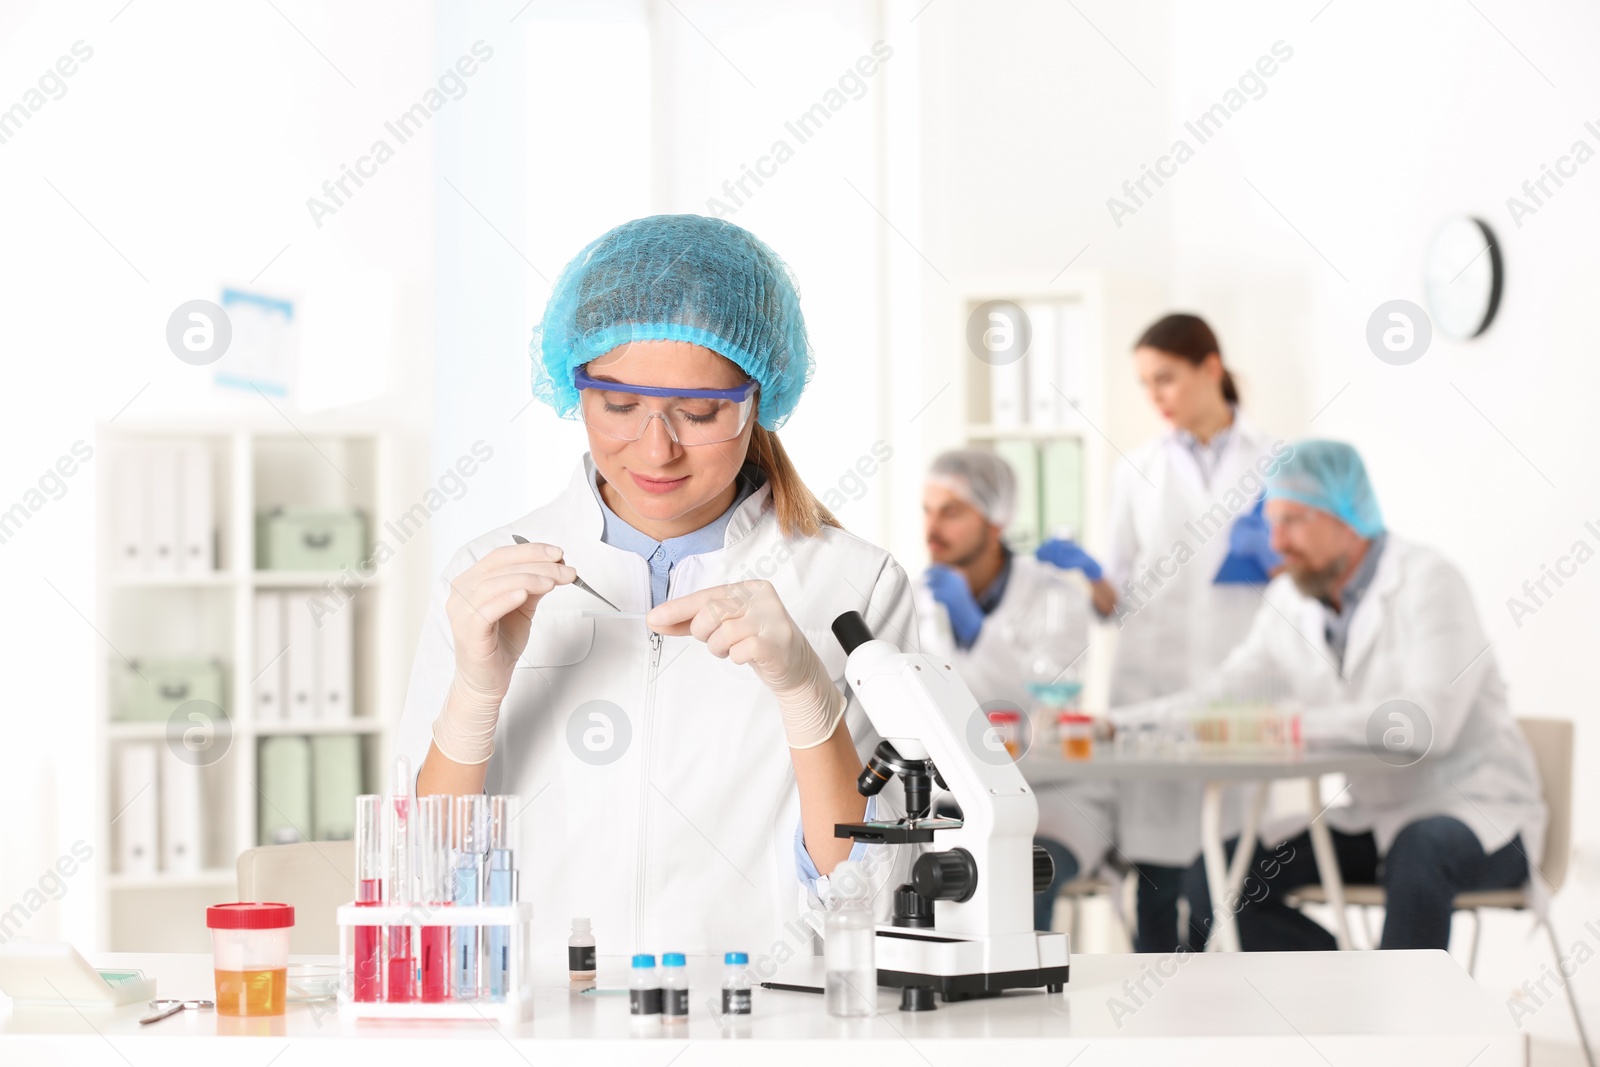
1018 745 1394 952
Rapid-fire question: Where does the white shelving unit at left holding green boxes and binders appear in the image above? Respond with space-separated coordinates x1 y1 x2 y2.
93 416 408 952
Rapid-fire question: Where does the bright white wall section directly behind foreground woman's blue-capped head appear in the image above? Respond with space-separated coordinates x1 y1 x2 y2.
434 0 893 563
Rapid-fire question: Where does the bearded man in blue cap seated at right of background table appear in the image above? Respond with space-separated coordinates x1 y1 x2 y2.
1152 440 1546 950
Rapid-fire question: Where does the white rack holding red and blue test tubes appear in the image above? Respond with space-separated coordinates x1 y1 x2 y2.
334 901 533 1025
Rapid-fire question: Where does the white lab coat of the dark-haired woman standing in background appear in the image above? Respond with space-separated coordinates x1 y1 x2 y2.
1102 408 1286 867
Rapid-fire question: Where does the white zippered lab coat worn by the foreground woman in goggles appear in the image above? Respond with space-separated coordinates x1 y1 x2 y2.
397 454 917 961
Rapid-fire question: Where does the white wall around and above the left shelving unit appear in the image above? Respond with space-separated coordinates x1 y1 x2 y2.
0 0 438 945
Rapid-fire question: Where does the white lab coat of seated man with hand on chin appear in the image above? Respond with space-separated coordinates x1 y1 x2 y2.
917 555 1115 875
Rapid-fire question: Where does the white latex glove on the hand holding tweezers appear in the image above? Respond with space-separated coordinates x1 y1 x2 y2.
434 541 578 763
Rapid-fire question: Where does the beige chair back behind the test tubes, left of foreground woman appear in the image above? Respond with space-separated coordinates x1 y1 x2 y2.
234 841 355 955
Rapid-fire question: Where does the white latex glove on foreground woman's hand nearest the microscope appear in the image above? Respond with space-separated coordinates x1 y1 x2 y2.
645 579 845 749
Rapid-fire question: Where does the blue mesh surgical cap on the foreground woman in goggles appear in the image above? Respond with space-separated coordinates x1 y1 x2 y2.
531 214 811 430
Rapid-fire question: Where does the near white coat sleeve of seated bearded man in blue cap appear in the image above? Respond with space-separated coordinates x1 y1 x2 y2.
1304 558 1496 757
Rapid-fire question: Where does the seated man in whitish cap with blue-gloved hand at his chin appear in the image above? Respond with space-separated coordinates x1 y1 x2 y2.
917 450 1112 929
